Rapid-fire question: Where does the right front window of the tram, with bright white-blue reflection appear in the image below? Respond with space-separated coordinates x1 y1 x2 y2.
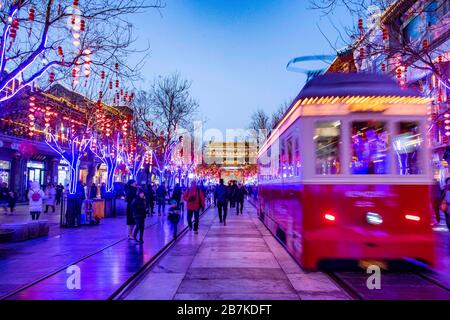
394 122 423 175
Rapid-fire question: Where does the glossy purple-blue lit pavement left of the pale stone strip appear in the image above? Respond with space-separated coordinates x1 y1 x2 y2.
0 205 197 299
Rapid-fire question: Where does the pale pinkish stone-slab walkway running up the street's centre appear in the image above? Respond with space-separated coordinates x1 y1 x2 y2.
126 203 350 300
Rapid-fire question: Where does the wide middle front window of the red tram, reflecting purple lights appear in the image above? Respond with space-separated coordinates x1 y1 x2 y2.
350 121 388 174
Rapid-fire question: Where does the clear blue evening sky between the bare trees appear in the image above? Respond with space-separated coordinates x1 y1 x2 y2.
132 0 350 135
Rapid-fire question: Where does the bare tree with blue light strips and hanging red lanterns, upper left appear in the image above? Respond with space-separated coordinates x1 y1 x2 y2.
0 0 161 102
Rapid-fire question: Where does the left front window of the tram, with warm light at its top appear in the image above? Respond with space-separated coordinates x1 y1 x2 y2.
314 121 341 175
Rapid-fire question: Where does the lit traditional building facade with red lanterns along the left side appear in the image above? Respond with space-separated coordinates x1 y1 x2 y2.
0 85 133 201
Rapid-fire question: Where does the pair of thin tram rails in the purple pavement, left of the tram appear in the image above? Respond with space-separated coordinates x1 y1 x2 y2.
0 206 210 300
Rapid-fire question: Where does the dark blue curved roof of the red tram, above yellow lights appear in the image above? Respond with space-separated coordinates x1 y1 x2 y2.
295 73 420 100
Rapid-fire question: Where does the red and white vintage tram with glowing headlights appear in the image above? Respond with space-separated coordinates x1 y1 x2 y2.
258 74 435 269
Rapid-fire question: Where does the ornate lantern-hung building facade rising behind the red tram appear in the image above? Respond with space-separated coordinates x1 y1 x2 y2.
327 0 450 183
